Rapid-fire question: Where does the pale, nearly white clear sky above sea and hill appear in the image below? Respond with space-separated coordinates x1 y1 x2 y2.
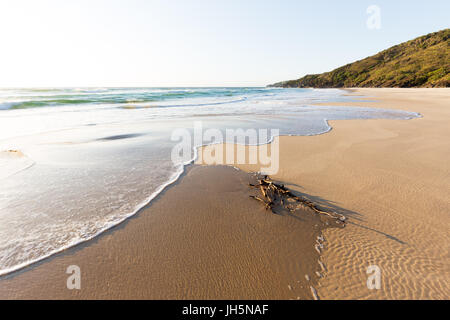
0 0 450 87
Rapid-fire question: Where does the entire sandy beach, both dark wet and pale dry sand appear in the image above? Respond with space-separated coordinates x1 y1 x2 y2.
0 89 450 299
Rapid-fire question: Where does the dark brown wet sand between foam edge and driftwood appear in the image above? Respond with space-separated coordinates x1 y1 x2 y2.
0 165 325 299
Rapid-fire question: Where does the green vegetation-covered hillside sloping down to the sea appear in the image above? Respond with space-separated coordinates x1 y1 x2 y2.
271 29 450 88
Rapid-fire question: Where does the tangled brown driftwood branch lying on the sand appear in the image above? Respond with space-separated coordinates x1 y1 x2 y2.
249 176 345 223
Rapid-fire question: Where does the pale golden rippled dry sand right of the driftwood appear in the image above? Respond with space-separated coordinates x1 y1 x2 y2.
199 89 450 299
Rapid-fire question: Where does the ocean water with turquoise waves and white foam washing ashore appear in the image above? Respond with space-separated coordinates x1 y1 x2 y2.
0 87 420 275
